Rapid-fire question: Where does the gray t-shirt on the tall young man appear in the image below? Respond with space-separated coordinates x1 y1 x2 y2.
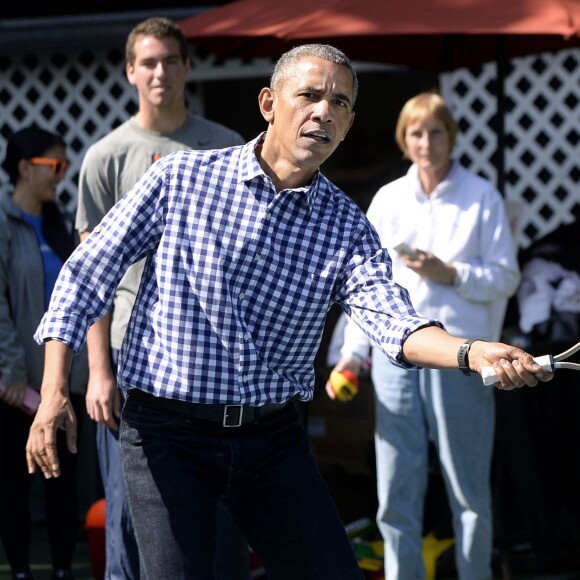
75 114 245 349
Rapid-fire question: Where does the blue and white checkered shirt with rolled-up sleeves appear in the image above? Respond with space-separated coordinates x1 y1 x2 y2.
35 136 438 405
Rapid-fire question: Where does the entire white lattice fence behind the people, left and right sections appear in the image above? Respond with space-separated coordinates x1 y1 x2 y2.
0 47 580 248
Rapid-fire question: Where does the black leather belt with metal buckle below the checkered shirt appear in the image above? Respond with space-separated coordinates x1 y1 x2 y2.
128 389 286 427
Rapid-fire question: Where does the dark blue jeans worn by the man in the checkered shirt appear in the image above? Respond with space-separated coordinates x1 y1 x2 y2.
121 394 363 580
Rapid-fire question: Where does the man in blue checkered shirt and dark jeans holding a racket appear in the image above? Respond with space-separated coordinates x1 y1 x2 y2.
27 45 551 580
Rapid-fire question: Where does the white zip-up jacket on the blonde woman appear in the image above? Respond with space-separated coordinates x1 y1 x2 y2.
341 161 520 358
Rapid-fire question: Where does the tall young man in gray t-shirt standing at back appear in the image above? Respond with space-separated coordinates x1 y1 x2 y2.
76 18 249 580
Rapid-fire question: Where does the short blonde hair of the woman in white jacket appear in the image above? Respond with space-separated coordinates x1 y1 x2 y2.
395 91 459 157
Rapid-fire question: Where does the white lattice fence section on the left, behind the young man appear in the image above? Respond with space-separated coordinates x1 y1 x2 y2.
0 47 203 212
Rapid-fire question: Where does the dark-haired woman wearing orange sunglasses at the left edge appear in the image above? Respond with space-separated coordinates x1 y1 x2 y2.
0 126 88 580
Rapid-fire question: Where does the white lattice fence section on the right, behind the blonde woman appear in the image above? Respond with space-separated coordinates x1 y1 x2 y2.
441 49 580 248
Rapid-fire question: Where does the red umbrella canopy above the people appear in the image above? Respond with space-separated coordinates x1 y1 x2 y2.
180 0 580 70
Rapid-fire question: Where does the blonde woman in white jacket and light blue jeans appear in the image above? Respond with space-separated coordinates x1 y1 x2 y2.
339 92 520 580
